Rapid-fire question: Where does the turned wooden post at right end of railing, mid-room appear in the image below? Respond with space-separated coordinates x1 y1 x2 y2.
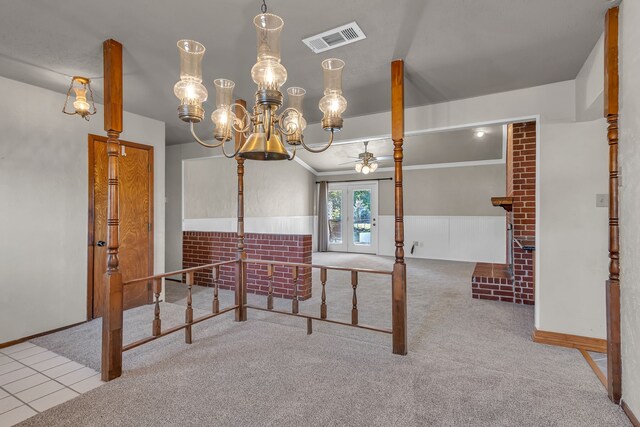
391 60 407 355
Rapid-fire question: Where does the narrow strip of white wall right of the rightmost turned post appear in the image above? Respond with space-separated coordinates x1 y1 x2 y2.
619 1 640 417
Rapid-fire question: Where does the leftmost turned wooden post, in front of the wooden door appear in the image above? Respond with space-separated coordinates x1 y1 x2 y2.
101 39 124 381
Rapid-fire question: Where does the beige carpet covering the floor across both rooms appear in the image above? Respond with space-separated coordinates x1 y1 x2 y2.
24 254 629 426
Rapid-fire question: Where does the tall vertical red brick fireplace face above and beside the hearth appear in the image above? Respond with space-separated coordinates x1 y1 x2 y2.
513 121 536 304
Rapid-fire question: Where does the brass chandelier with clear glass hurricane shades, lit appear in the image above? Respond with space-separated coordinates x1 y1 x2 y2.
174 2 347 160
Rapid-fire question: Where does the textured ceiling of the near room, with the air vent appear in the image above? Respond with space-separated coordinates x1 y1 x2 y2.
0 0 608 144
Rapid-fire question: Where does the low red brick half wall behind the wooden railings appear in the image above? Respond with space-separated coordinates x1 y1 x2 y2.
182 231 312 300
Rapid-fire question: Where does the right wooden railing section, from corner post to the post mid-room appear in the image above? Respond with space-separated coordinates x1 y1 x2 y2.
244 259 393 334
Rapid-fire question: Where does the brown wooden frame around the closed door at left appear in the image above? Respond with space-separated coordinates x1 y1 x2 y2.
87 133 155 320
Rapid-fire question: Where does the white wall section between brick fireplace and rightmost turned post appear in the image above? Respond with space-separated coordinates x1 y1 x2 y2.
536 119 609 338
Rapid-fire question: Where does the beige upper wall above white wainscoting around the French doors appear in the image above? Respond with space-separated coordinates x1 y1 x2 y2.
318 164 506 216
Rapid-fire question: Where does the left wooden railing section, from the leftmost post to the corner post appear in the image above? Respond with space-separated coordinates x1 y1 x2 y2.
122 260 239 352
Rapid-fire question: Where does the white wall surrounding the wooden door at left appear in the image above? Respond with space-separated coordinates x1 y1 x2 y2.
0 77 165 343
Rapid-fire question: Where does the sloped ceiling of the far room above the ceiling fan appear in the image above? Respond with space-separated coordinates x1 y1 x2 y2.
297 125 503 172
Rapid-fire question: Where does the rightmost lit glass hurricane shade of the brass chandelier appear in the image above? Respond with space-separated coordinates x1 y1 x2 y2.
318 58 347 131
